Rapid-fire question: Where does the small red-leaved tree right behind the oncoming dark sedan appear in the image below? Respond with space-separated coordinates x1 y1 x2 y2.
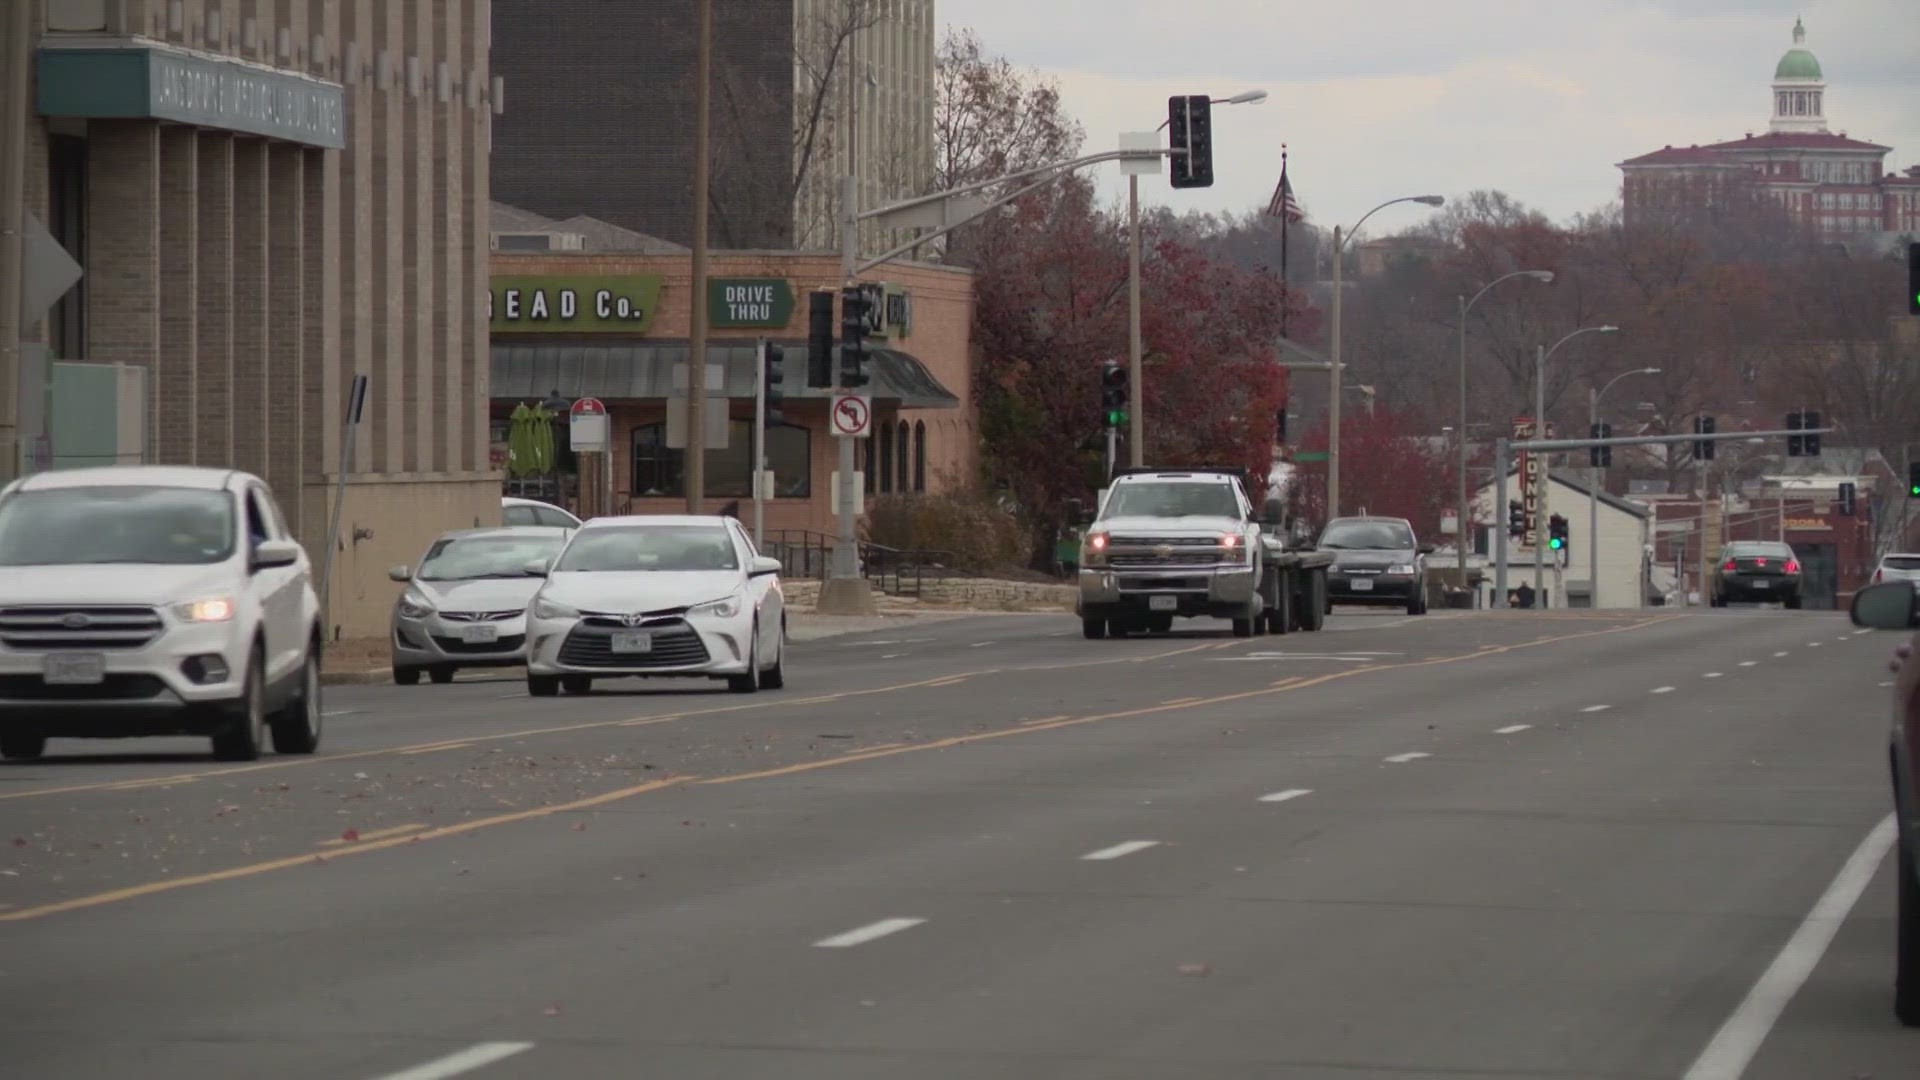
1294 409 1457 540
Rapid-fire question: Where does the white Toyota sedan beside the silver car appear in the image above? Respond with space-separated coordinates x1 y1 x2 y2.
526 515 787 698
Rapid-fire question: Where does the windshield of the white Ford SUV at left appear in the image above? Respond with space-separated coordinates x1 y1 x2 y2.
0 486 236 567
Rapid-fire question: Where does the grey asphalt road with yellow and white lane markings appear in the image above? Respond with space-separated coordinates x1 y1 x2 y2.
0 609 1920 1080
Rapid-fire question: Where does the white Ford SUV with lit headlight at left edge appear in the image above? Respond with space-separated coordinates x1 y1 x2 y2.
0 465 323 761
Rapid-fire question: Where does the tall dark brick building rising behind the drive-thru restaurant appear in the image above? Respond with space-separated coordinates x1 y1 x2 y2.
493 0 935 252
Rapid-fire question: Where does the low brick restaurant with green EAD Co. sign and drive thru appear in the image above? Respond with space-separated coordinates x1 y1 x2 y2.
492 236 979 532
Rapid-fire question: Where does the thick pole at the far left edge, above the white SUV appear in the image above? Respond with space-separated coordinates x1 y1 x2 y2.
0 0 38 482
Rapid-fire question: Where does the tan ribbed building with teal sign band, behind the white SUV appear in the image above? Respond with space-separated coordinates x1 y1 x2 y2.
8 0 499 636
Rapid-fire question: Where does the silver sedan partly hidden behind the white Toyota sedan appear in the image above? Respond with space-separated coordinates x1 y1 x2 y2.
388 525 568 686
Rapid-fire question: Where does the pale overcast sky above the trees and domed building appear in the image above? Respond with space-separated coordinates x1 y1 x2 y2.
939 0 1920 234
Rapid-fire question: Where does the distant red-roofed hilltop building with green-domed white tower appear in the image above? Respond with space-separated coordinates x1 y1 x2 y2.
1619 19 1920 242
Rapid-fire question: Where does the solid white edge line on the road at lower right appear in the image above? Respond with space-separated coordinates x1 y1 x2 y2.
1686 815 1895 1080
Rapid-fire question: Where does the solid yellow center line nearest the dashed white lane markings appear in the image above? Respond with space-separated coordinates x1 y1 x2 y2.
0 615 1680 922
